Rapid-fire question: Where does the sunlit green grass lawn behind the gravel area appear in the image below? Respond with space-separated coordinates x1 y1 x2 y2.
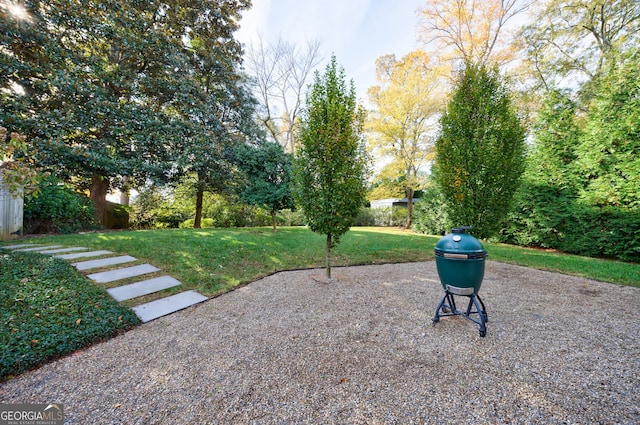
6 227 640 296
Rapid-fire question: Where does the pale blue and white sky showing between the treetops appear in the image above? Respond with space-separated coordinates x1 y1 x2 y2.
236 0 425 102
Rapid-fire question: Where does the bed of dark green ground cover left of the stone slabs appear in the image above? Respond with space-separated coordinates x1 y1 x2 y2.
0 252 139 380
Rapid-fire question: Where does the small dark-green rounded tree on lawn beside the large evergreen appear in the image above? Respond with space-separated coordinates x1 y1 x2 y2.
238 141 294 232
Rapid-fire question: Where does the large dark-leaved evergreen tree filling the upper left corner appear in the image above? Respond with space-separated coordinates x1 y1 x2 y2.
0 0 249 225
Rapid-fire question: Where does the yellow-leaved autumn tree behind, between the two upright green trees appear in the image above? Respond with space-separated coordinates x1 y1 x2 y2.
368 51 443 228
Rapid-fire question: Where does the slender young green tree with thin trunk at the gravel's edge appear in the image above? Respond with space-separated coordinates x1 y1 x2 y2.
293 56 368 279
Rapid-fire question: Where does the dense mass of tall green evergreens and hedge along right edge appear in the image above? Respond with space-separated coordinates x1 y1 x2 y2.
500 51 640 261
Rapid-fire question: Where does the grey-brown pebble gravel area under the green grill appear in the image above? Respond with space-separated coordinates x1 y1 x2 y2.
0 261 640 424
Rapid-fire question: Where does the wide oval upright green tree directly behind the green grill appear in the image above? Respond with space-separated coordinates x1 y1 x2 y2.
435 64 526 238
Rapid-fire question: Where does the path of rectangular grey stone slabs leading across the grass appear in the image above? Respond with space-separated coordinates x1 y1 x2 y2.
0 244 208 323
